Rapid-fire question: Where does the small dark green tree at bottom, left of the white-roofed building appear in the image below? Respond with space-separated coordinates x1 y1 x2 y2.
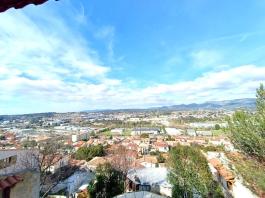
88 163 124 198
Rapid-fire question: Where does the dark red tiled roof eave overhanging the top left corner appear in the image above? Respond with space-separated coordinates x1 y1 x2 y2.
0 0 48 12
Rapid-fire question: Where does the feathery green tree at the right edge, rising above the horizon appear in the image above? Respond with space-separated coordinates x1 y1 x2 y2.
228 84 265 162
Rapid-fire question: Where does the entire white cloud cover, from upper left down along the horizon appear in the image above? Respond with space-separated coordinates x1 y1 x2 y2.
0 5 265 114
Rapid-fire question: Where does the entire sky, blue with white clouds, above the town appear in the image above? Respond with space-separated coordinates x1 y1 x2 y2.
0 0 265 114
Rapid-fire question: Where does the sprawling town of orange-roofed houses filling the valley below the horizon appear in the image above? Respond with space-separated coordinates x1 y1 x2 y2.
0 110 256 197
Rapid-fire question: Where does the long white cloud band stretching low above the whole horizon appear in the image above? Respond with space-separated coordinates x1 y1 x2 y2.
0 62 265 111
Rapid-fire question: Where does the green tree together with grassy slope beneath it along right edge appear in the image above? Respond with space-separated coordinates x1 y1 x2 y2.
228 84 265 197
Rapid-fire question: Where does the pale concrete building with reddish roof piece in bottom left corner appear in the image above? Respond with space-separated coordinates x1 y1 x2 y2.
0 150 40 198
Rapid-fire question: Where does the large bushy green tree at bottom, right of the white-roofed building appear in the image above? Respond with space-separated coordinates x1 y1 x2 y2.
168 145 223 198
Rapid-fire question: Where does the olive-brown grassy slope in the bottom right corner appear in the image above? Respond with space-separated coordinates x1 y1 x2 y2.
227 154 265 197
